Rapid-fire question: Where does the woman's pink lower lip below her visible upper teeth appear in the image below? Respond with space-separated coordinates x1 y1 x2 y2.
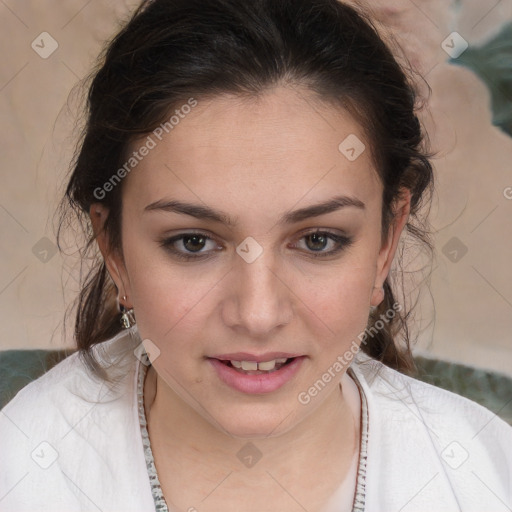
209 356 305 395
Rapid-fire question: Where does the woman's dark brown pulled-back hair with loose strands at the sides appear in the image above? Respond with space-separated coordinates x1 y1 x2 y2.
58 0 433 380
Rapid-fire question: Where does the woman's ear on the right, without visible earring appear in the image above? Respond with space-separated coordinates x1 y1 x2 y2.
370 188 411 306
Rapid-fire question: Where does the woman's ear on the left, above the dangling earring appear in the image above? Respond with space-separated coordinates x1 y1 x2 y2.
89 203 131 309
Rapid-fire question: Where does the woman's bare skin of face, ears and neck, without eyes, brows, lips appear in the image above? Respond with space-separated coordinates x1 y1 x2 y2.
90 86 410 512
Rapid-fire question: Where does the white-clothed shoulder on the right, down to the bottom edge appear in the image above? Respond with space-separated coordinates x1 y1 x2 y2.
353 354 512 512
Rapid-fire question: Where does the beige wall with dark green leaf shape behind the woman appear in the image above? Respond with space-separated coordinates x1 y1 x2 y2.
0 0 512 376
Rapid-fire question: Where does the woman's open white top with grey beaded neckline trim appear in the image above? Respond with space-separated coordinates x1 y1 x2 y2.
0 328 512 512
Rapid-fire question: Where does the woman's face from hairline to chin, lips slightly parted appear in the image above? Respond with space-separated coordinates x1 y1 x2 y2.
91 88 407 437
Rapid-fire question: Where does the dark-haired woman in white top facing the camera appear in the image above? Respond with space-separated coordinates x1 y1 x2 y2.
0 0 512 512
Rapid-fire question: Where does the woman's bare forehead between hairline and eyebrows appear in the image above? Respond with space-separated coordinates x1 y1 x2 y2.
122 87 380 213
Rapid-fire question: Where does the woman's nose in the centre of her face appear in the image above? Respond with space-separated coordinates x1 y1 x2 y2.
222 251 294 338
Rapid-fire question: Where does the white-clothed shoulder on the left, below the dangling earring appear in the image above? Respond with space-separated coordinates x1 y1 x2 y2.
0 332 147 512
